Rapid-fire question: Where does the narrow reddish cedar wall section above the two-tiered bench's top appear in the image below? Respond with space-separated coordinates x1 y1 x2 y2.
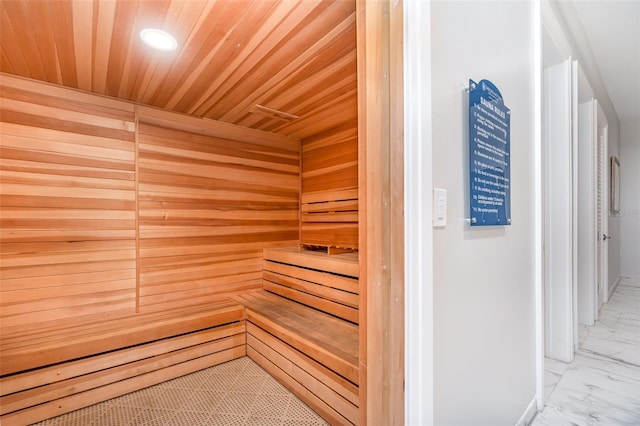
301 120 358 249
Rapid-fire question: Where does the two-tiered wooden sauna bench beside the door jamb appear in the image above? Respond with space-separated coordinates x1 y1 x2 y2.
234 248 359 425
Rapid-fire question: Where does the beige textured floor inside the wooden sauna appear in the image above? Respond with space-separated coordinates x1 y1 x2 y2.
31 357 327 426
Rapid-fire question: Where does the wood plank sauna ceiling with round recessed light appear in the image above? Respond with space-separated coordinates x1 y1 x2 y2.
0 0 357 138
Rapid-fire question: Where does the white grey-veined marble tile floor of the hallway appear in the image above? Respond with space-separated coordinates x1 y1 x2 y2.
531 279 640 426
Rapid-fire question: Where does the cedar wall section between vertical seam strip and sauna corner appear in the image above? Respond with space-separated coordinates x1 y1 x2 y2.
139 118 300 310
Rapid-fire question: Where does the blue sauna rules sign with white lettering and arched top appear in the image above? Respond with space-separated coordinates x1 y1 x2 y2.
469 80 511 226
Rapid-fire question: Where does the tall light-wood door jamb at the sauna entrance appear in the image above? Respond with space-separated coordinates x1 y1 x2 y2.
356 0 405 425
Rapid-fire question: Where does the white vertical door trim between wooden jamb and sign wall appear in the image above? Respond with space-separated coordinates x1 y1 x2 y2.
403 0 434 425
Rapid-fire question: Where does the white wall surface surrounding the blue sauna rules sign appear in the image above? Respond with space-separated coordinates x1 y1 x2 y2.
431 1 536 426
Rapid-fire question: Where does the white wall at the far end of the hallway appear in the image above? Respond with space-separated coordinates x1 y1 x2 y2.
619 119 640 278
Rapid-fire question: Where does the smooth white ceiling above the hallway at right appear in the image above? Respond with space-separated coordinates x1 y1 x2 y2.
574 0 640 121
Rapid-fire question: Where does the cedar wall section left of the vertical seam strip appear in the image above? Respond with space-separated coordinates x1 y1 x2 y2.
0 76 136 330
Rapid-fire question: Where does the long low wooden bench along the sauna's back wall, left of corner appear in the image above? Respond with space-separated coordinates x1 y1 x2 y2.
0 299 246 426
